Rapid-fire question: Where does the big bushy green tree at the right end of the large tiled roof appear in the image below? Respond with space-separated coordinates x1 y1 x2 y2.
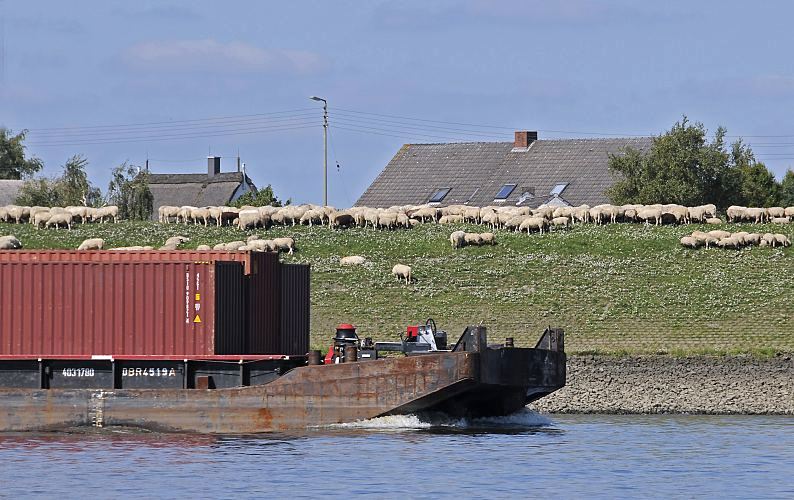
607 116 765 208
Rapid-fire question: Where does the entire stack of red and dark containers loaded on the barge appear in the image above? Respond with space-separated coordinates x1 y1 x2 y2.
0 251 309 356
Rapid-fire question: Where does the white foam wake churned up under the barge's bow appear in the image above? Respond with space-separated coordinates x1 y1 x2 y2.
333 408 552 430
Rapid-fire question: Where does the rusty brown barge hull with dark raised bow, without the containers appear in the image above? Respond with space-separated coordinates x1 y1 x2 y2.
0 348 565 434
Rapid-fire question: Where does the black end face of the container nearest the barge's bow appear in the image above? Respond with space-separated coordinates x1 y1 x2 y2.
279 264 311 354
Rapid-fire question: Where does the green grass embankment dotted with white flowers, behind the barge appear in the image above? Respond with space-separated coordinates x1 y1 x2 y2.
0 222 794 355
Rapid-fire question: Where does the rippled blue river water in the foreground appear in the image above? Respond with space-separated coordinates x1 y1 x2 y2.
0 410 794 500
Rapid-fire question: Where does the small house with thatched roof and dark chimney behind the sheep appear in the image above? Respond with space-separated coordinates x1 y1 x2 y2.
149 156 256 218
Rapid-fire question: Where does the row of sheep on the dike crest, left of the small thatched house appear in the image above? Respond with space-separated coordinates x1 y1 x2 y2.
0 205 119 229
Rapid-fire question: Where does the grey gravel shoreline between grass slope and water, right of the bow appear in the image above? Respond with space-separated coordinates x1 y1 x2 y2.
530 355 794 415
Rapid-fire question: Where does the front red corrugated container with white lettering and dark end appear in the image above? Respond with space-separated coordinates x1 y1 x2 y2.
0 262 246 356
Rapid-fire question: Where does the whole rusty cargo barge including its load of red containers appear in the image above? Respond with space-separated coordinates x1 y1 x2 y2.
0 252 565 433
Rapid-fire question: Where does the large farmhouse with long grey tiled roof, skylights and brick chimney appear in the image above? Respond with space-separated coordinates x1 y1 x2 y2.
356 131 652 208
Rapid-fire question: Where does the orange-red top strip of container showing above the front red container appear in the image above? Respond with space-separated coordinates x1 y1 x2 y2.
0 250 266 274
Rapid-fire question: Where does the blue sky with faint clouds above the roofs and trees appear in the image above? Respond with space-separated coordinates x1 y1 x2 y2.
0 0 794 207
